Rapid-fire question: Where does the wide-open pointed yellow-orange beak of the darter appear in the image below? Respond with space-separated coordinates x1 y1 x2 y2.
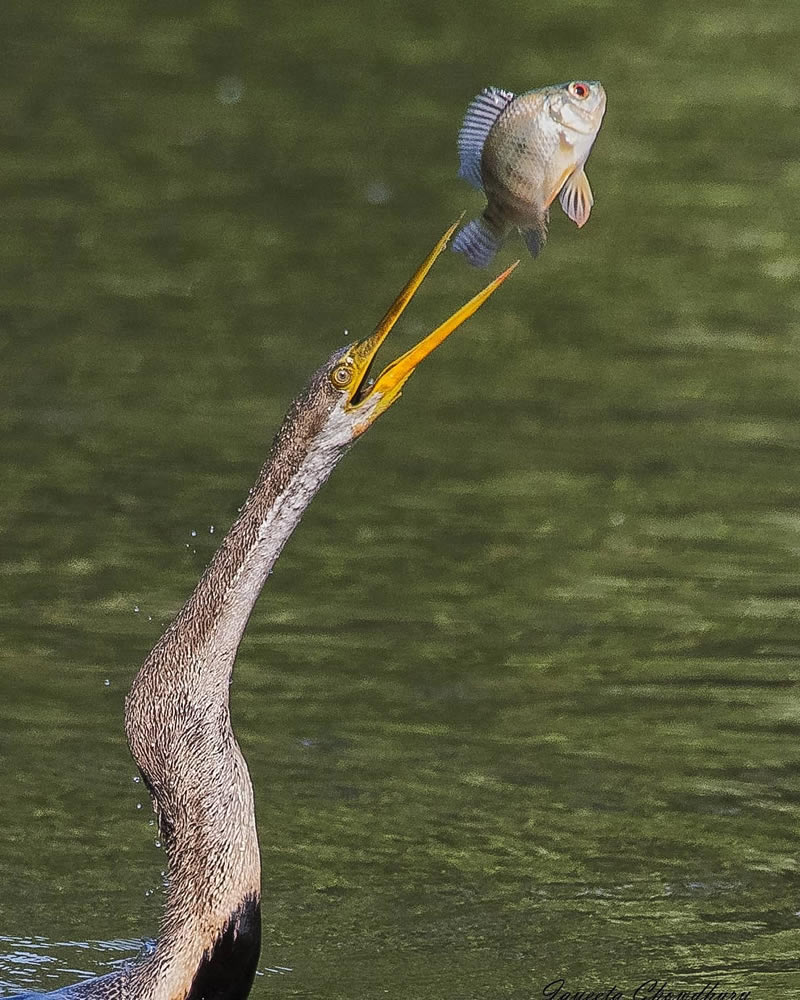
346 219 519 423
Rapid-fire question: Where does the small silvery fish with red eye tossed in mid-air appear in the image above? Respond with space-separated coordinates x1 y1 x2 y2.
452 80 606 267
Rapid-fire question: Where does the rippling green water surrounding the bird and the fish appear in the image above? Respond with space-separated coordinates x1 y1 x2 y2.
0 0 800 1000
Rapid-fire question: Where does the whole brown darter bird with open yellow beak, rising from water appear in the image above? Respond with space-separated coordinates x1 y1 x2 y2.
4 226 513 1000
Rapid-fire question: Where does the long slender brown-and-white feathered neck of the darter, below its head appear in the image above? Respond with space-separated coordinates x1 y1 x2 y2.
126 404 344 1000
